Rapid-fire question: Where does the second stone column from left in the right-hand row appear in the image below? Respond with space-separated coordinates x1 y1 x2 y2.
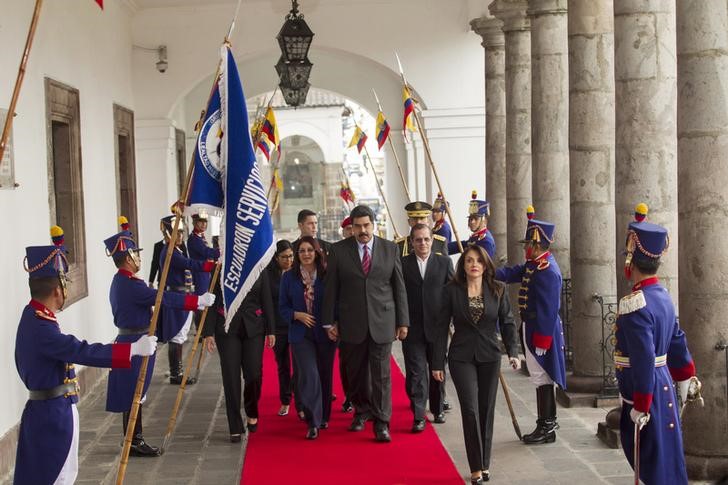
488 0 531 272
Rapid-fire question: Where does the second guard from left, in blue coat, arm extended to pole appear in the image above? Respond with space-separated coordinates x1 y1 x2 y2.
104 225 214 456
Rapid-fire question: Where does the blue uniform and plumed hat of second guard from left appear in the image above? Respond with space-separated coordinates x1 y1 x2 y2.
104 231 197 413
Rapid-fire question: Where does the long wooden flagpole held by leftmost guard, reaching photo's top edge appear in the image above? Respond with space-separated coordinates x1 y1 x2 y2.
116 0 241 472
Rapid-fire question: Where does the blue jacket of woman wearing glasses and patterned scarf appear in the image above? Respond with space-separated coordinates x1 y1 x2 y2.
278 270 329 344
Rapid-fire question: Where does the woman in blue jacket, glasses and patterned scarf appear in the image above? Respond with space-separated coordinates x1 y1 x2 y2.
279 236 336 440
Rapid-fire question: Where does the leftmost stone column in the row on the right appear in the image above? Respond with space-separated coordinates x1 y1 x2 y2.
470 17 508 265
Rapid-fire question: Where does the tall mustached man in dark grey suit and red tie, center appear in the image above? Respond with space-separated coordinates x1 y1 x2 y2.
322 206 409 442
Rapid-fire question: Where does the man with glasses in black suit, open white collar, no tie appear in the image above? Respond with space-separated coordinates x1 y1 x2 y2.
402 224 453 433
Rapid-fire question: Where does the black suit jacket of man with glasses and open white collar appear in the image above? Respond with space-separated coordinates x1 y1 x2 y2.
402 252 453 343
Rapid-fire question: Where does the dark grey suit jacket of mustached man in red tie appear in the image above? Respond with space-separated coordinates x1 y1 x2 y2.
323 236 409 344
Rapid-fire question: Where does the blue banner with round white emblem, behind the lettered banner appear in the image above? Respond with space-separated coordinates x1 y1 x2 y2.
185 77 224 215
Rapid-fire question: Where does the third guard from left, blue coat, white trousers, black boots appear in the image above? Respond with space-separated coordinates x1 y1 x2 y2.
157 216 215 385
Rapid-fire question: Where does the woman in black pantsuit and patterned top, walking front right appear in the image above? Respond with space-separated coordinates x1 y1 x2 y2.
432 245 519 484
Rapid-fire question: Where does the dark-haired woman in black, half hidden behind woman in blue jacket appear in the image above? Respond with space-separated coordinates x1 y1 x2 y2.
260 239 295 416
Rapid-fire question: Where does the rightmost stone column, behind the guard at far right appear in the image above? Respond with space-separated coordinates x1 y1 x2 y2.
672 0 728 480
